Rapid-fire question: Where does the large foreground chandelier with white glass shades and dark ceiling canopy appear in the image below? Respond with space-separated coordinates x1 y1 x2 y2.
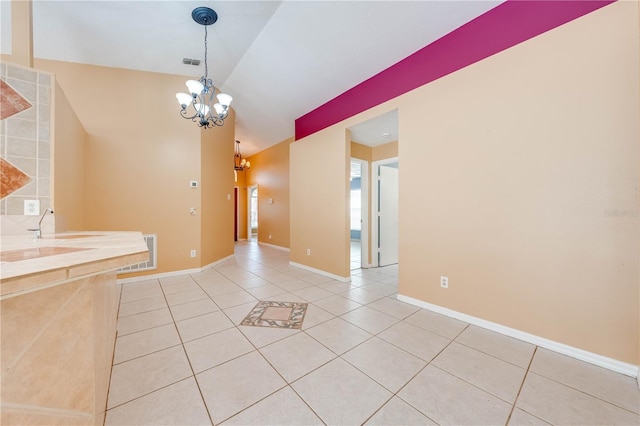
176 7 233 129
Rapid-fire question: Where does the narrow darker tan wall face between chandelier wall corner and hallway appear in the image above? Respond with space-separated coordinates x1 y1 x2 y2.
199 115 235 266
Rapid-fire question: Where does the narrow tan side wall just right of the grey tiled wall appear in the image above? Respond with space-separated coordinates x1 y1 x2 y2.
52 82 87 232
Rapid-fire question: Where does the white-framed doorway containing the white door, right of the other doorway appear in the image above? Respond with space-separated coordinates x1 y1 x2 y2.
372 158 399 266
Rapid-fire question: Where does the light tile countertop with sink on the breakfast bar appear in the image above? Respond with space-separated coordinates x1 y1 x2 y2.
0 231 149 299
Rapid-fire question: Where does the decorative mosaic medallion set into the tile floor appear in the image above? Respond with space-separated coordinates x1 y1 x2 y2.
240 301 307 329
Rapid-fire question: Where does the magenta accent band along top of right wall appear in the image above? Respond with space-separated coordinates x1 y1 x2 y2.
295 0 615 140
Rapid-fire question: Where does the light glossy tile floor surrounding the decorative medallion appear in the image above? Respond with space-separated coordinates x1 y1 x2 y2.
106 243 640 425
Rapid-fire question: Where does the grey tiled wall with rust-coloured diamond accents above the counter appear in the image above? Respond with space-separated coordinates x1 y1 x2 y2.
0 63 53 234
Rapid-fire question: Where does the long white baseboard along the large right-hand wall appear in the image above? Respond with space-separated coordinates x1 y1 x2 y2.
397 294 638 378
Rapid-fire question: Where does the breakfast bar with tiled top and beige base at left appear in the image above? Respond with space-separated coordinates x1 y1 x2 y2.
0 232 149 425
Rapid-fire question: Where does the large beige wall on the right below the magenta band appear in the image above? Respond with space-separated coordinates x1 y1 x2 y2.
291 2 640 364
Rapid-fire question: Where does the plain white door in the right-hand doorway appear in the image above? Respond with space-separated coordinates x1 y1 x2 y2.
378 163 398 266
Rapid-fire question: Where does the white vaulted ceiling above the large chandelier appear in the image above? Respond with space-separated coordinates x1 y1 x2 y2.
0 0 503 155
